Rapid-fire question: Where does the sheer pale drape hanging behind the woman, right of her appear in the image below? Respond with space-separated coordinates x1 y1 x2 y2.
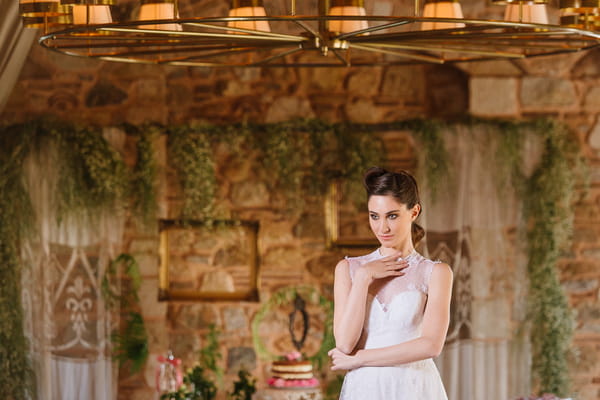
422 126 530 400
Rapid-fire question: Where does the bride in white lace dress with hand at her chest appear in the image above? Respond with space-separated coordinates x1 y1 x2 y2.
329 167 452 400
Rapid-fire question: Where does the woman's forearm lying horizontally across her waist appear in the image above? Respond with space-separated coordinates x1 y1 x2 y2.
355 337 443 367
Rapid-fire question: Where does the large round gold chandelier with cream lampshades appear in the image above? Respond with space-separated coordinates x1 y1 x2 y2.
20 0 600 67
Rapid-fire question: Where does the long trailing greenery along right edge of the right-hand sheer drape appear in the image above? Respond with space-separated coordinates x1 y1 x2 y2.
524 122 581 396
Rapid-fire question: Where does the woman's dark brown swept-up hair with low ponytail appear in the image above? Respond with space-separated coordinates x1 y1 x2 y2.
363 167 425 246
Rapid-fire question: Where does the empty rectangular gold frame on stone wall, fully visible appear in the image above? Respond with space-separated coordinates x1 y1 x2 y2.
159 220 258 301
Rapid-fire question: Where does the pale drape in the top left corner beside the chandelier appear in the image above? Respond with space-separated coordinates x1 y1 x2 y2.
0 0 37 113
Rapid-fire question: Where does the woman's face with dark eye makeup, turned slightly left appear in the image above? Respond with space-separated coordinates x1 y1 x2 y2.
367 196 420 249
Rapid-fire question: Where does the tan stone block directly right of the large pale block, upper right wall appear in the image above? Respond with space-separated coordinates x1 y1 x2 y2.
521 76 579 111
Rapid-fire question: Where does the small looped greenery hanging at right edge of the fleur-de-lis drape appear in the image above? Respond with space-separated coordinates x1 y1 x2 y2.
102 254 148 373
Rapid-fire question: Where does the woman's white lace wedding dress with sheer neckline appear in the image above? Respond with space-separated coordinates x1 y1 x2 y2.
340 250 447 400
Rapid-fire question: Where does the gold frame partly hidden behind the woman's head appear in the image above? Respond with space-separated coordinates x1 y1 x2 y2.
325 180 379 250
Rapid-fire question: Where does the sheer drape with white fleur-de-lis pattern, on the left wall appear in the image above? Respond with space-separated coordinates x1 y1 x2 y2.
22 132 123 400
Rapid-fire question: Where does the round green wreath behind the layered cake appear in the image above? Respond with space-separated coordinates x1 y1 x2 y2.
252 285 335 370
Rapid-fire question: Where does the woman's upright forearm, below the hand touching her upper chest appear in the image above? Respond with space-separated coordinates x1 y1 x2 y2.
334 271 371 354
